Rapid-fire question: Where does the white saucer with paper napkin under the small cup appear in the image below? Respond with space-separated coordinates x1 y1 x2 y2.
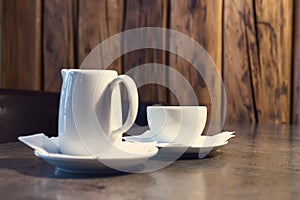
123 130 235 158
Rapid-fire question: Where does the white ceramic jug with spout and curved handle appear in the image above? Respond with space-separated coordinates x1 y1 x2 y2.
58 69 138 156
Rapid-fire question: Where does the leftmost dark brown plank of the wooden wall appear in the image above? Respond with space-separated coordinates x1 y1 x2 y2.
2 0 41 90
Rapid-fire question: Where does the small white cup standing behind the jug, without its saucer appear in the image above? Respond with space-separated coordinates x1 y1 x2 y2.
147 106 207 146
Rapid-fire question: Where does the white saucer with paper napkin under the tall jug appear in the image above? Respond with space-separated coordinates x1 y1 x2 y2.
18 134 158 174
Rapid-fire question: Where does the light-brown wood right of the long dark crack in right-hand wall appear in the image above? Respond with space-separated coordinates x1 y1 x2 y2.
252 0 293 123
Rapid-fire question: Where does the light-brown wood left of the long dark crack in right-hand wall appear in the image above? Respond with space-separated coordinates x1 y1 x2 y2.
223 0 258 122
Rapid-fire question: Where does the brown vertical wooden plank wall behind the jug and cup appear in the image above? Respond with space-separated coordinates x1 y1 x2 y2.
0 0 300 124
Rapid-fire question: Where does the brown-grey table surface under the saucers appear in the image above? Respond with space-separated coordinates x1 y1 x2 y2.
0 124 300 200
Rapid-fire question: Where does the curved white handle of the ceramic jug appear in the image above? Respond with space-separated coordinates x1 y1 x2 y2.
109 75 139 134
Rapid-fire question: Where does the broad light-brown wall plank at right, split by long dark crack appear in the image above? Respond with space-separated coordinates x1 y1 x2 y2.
223 0 293 123
